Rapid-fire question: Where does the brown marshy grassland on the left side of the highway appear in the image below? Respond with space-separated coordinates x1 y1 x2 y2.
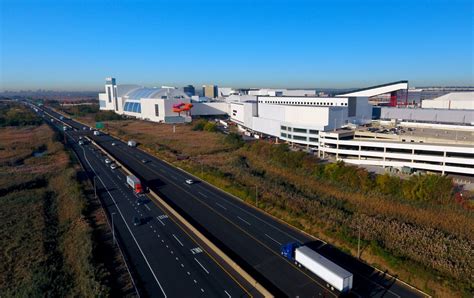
0 102 114 297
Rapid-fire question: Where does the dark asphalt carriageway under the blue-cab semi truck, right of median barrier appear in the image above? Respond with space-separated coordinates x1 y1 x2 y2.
39 103 425 297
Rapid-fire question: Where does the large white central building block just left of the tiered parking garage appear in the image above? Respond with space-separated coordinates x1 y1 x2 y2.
230 96 372 146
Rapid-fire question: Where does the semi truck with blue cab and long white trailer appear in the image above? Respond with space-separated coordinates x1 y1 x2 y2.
281 242 353 293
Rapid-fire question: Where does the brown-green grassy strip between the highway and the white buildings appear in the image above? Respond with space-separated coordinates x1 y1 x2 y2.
64 107 474 297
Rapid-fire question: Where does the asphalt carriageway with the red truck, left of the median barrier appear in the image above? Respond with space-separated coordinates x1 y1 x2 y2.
42 115 254 297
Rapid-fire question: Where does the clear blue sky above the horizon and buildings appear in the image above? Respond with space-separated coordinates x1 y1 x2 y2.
0 0 474 90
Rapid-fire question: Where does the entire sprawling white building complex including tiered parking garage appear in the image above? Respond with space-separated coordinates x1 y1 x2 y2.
99 78 474 175
